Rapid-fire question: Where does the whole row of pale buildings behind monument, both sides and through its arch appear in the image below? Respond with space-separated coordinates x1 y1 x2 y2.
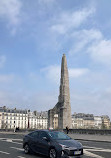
0 106 111 129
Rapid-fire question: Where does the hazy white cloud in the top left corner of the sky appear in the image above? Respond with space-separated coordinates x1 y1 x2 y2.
0 0 22 33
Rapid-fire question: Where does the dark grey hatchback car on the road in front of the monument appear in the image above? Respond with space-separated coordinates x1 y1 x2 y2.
23 130 83 158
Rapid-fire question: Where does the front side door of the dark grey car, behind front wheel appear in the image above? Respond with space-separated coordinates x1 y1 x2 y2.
39 131 50 155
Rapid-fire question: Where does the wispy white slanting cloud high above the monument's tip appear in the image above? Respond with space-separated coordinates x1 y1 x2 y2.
51 9 95 34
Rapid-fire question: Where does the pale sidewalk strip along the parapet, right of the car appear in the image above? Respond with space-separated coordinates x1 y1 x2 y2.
68 134 111 143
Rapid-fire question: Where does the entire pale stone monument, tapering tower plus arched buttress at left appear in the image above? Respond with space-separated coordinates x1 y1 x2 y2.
48 54 72 129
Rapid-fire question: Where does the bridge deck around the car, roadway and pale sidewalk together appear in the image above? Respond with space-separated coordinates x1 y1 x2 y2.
0 131 111 158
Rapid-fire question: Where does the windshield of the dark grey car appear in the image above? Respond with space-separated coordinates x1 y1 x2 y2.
48 131 71 140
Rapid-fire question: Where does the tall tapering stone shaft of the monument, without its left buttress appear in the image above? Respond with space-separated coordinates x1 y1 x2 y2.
58 54 71 128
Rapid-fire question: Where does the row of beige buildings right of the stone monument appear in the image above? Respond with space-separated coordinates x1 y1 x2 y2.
72 113 110 129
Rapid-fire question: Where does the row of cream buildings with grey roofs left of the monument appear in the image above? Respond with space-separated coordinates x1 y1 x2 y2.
0 106 48 129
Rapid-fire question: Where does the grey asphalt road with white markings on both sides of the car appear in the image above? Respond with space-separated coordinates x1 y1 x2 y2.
0 133 111 158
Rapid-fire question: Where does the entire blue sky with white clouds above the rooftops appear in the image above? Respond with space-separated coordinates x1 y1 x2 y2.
0 0 111 118
